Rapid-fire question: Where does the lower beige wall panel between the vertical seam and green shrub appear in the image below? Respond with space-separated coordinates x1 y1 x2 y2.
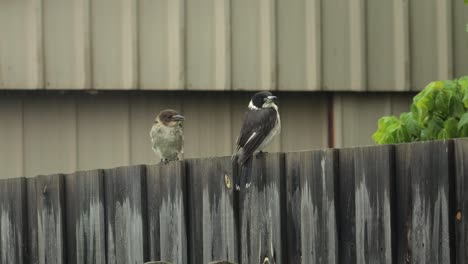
333 93 414 147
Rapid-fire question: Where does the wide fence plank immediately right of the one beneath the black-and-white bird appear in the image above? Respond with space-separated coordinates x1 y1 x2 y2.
285 149 338 264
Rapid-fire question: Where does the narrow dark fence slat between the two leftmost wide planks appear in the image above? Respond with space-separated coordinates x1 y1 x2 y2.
26 177 39 263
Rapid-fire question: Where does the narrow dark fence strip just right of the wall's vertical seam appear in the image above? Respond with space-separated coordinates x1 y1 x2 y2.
335 148 356 264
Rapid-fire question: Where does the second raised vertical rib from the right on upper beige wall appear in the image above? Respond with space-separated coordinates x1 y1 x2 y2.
393 0 410 91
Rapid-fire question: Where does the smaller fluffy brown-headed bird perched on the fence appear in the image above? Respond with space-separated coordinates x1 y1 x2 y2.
150 109 185 164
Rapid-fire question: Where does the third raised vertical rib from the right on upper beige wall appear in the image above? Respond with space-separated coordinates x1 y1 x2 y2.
348 0 367 91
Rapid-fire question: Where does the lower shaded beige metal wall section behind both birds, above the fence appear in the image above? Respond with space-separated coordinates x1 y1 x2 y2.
0 92 411 178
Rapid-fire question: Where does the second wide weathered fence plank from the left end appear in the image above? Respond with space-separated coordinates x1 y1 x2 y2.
36 175 66 264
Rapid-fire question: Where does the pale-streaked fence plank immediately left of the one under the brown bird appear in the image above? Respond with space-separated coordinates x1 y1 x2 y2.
104 166 147 264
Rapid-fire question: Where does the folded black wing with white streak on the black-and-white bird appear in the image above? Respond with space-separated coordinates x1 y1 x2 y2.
236 108 277 164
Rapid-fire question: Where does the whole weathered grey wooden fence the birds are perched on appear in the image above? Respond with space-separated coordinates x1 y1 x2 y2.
0 139 468 264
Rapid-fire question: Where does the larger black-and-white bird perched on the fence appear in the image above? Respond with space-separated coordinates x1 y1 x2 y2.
233 91 281 166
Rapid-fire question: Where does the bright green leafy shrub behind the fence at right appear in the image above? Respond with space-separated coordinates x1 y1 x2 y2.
372 76 468 144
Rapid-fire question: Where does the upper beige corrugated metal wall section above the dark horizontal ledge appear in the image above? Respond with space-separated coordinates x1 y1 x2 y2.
0 0 468 91
